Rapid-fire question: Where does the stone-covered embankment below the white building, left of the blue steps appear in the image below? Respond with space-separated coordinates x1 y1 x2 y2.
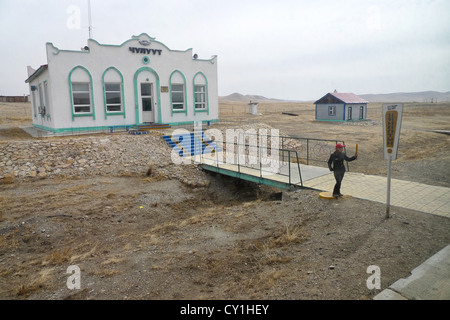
0 132 204 184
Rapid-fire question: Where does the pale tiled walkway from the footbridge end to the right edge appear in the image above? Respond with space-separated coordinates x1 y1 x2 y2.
303 172 450 218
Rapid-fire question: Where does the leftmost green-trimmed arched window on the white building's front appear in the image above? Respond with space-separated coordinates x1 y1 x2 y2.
69 66 95 121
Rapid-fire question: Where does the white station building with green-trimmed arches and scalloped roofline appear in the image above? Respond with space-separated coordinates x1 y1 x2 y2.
25 33 218 133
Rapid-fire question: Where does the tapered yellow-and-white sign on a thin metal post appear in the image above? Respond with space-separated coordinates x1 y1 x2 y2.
382 104 403 219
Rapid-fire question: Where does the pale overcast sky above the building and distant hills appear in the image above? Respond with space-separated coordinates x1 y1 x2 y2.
0 0 450 100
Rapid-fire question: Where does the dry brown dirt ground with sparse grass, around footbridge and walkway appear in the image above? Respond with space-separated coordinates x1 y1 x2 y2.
0 102 450 300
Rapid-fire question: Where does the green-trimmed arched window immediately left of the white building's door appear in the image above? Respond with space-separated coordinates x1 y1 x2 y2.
102 67 125 119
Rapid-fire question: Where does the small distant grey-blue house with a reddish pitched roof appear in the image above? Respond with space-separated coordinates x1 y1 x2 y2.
314 91 369 121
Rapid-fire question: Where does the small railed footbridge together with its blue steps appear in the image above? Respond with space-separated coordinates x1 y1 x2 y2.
163 131 343 189
